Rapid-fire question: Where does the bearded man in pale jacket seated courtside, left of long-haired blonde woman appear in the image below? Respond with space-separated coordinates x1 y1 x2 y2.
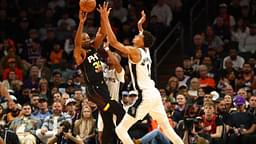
36 101 71 143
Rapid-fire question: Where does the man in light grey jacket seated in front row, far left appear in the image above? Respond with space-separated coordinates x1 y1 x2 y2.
9 104 40 144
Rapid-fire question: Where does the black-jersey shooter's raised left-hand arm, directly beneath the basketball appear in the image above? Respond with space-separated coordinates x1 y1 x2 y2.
74 11 87 65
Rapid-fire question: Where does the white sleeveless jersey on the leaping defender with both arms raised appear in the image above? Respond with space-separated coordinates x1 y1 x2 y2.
129 48 155 90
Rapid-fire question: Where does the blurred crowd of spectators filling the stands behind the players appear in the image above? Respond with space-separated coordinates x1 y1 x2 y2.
0 0 256 144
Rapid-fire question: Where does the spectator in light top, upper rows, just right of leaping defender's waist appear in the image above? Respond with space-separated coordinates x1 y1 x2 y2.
175 66 190 87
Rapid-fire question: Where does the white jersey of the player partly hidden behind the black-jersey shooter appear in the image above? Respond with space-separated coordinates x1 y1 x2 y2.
103 64 125 101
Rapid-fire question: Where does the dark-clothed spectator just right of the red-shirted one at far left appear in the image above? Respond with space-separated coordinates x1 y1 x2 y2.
24 65 40 89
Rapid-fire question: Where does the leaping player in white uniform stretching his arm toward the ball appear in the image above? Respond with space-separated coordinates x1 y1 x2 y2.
98 3 183 144
